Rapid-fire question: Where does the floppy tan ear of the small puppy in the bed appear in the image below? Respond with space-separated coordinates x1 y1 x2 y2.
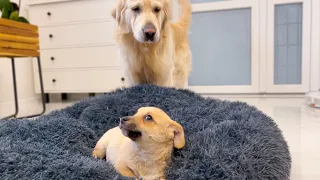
168 121 185 149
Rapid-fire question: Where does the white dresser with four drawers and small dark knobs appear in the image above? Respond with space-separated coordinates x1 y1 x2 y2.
29 0 125 93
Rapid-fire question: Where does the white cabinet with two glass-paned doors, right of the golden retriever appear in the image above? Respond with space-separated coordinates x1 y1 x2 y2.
188 0 320 93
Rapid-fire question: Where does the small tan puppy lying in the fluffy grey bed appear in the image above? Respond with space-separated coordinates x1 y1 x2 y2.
92 107 185 180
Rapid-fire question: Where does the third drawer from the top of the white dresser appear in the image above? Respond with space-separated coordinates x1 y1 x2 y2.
41 46 120 70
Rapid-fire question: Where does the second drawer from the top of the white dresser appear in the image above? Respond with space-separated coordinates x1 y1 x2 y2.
39 21 115 49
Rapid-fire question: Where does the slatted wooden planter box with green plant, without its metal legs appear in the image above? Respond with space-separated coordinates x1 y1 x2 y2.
0 0 39 57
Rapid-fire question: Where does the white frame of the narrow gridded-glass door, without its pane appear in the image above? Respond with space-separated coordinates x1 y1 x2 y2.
266 0 311 93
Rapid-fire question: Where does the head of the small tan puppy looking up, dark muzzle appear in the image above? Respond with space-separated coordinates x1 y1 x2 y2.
119 107 185 149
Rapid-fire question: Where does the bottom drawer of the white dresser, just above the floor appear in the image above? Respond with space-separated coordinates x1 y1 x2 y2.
35 69 125 93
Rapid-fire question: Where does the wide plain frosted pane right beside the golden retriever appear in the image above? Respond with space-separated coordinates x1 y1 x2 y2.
189 8 251 86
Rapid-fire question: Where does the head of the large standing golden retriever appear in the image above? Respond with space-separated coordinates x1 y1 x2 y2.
111 0 171 43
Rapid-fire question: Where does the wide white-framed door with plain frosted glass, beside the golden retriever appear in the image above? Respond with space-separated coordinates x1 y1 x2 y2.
188 0 259 93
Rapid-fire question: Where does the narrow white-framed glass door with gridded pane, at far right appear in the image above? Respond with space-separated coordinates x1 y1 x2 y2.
266 0 311 93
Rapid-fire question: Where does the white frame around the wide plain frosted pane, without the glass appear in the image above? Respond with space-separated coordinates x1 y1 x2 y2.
187 0 260 94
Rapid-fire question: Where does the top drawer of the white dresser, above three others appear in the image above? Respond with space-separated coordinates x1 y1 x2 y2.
30 0 116 27
